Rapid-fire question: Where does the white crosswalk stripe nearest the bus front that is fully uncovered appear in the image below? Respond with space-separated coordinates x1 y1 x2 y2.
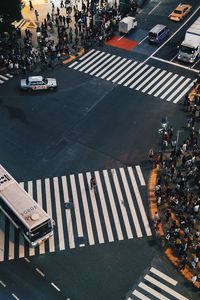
53 177 65 250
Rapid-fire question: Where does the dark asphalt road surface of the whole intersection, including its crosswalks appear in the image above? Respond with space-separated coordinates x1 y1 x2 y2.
0 1 200 300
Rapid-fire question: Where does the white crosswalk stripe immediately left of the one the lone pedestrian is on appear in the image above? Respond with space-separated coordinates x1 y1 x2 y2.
78 173 95 245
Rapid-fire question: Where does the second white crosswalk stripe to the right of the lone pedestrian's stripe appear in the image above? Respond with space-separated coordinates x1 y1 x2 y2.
103 170 124 241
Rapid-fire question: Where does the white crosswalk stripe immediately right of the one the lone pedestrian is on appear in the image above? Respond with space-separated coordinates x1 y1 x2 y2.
94 171 114 242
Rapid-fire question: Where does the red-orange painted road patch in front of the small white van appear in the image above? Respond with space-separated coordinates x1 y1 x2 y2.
105 36 138 51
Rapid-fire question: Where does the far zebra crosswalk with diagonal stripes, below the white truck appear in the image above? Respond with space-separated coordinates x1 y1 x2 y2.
69 49 194 103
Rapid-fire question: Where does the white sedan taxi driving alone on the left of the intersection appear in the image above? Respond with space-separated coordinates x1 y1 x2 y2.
21 76 57 91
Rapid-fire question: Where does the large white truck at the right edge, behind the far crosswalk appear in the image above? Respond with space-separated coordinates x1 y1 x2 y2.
177 17 200 63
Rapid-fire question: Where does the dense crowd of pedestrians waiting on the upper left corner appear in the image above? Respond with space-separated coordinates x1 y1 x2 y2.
0 0 120 73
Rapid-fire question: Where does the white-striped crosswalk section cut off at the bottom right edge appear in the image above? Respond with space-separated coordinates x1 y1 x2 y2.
127 267 189 300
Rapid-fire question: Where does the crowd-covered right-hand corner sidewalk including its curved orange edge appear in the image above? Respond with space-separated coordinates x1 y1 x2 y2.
149 118 200 288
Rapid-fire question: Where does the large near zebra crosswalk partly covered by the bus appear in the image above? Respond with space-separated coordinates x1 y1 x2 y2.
0 165 152 261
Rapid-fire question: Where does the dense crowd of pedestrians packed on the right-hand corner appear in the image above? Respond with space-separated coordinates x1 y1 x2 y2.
154 81 200 284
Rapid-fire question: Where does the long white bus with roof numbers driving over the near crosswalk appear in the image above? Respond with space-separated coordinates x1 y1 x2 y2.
0 165 54 247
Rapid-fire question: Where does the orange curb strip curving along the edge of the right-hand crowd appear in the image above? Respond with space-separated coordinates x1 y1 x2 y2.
148 166 200 289
